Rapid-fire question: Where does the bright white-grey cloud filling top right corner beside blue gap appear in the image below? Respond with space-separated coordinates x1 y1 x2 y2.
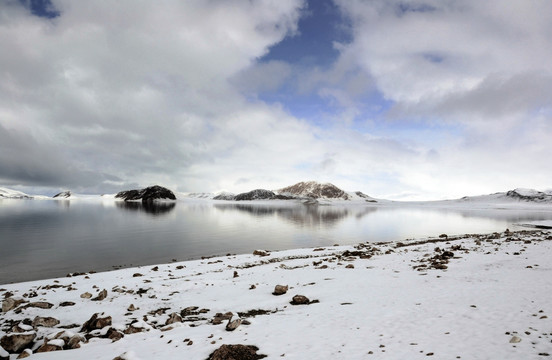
339 0 552 106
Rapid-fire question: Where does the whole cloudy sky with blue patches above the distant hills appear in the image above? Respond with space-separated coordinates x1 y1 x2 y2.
0 0 552 200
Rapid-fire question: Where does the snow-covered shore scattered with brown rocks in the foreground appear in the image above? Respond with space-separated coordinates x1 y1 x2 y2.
0 230 552 359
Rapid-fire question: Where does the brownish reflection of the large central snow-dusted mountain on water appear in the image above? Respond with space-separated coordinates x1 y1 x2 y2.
215 204 378 227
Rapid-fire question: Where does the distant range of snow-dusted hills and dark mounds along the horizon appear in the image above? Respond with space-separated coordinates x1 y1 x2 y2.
0 181 552 204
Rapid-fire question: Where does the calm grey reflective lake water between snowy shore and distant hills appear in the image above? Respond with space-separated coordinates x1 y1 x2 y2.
0 200 552 284
